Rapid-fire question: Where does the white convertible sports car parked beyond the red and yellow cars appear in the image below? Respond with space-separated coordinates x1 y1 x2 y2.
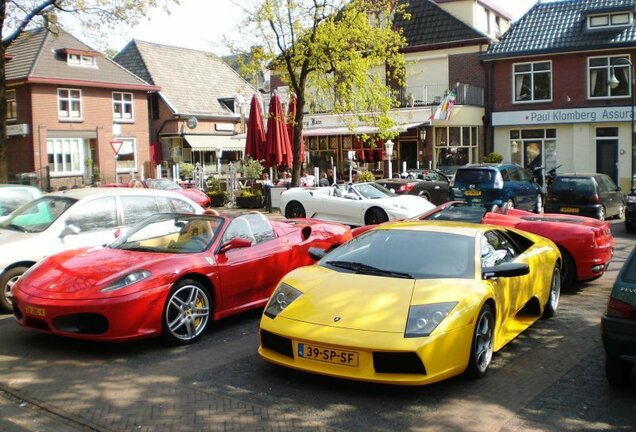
280 182 435 226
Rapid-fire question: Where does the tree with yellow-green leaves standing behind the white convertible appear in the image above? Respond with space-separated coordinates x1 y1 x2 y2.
234 0 406 185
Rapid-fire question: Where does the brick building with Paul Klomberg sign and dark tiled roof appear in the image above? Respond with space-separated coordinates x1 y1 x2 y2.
482 0 636 189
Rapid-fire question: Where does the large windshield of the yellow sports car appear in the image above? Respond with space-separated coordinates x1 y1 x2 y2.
318 229 475 279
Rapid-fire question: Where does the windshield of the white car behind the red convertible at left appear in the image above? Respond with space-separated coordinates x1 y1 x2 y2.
0 196 77 232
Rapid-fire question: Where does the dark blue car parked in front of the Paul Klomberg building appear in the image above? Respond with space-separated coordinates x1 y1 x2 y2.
452 163 543 213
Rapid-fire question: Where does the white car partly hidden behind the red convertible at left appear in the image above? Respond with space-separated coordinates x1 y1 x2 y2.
0 188 203 311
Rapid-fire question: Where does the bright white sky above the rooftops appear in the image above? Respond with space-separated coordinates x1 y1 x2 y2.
81 0 537 55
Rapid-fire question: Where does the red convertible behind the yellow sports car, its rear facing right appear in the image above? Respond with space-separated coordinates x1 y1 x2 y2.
353 201 616 286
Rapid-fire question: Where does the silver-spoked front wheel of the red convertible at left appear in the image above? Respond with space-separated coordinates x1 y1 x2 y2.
161 279 212 345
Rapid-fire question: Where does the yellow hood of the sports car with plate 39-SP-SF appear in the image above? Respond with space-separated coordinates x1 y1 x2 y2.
280 266 470 333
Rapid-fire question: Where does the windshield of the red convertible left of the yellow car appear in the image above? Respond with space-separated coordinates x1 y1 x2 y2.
109 214 223 253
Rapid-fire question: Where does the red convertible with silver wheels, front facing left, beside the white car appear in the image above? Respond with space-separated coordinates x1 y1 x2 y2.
13 213 351 344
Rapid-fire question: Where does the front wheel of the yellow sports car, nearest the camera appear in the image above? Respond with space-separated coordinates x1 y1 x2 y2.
466 304 495 379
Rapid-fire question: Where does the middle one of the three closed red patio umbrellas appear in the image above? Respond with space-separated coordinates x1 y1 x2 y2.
264 93 293 167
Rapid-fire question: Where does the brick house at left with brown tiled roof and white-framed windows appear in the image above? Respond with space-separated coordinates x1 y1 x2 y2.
6 29 159 189
